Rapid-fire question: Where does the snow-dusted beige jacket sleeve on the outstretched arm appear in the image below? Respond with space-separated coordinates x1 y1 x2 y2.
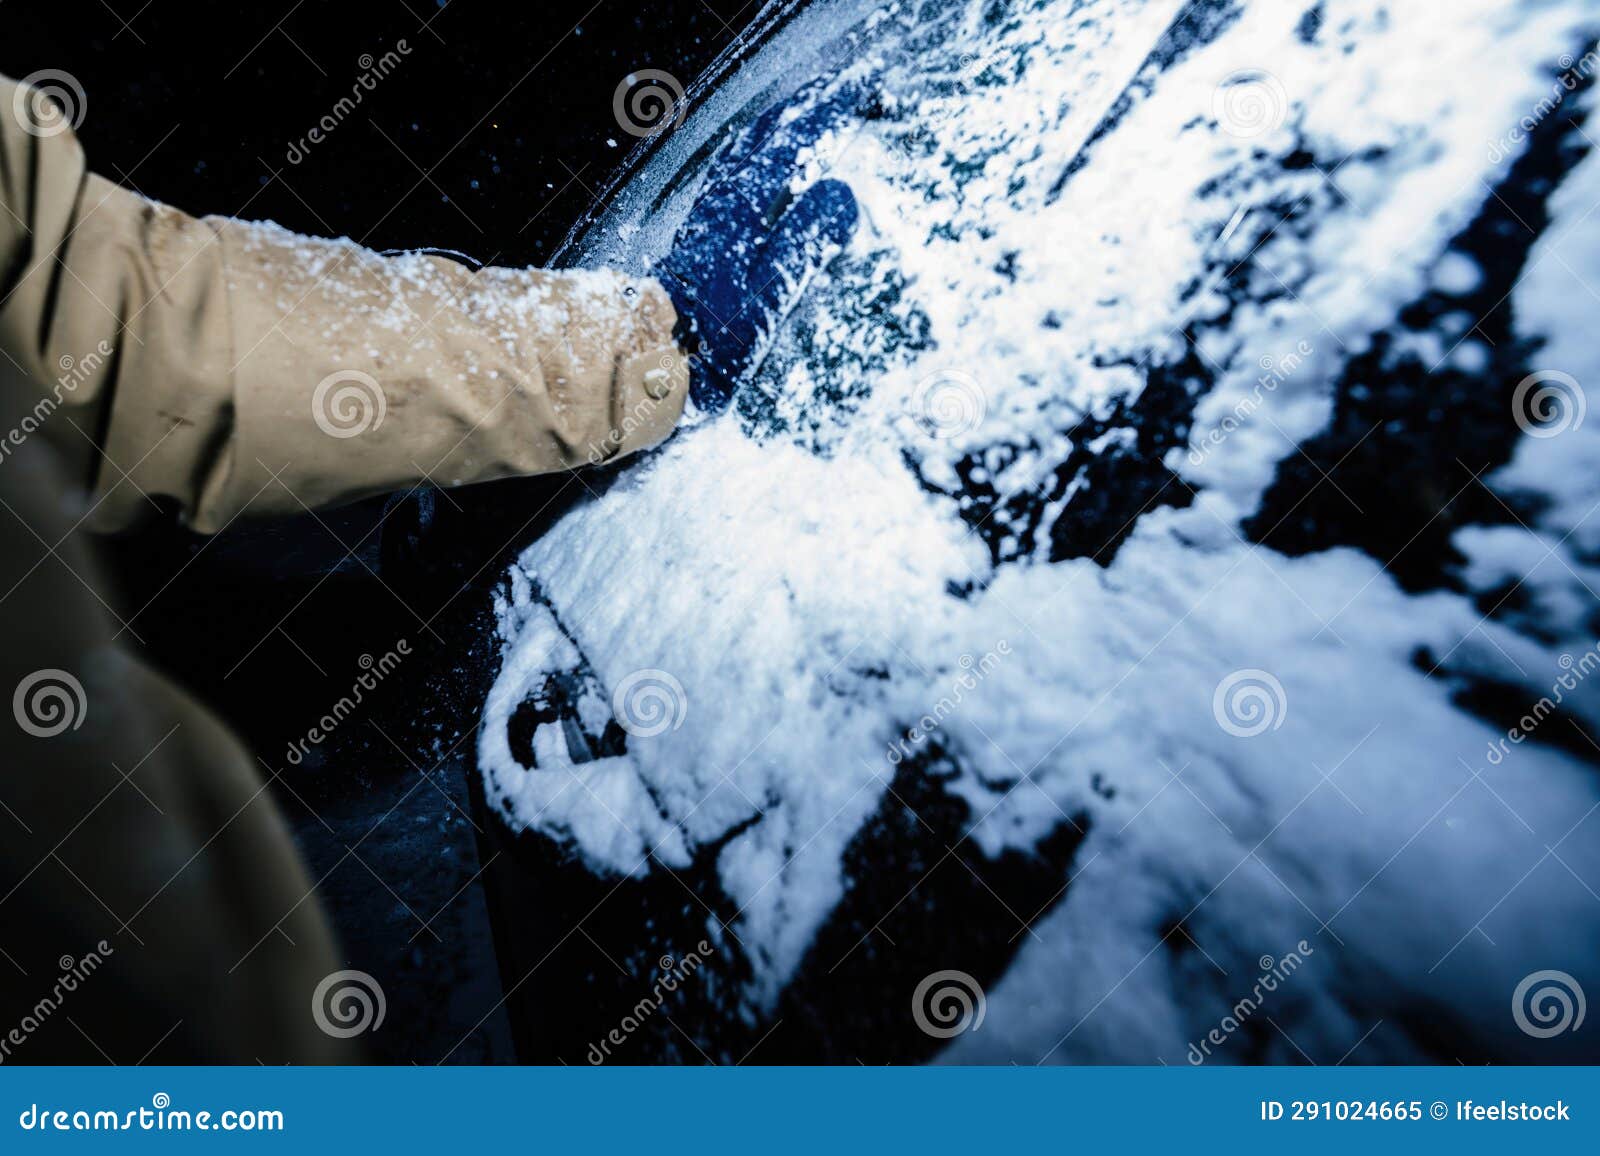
0 77 688 532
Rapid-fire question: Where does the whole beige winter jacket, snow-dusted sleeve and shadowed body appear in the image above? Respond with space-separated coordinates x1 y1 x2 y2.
0 77 686 1063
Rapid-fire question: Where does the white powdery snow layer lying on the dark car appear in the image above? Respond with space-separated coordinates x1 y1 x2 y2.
480 0 1600 1063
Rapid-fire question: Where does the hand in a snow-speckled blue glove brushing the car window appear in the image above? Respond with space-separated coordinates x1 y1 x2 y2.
653 85 859 413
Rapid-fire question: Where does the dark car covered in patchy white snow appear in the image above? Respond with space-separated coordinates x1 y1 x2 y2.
478 0 1600 1063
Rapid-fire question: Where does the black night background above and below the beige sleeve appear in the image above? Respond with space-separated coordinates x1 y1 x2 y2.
0 0 760 1062
